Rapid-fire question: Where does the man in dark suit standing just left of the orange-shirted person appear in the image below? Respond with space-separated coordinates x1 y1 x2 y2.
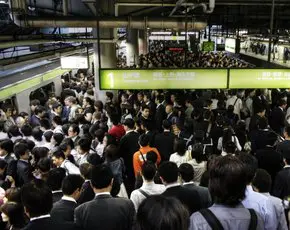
120 119 139 196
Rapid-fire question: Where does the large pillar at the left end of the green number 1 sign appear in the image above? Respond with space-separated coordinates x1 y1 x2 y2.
93 28 117 102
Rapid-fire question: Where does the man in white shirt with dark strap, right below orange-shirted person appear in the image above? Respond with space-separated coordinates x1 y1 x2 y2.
130 162 165 211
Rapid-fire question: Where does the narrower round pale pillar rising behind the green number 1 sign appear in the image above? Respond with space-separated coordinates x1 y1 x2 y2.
126 29 139 67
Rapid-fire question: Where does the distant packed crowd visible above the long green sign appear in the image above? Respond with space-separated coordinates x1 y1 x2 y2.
117 41 251 68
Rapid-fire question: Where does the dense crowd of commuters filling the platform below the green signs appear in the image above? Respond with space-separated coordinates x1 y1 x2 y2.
0 72 290 230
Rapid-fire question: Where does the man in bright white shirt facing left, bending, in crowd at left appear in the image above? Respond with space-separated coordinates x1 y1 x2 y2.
52 150 80 175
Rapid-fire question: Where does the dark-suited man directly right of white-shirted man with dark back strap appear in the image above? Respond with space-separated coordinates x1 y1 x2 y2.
158 161 202 215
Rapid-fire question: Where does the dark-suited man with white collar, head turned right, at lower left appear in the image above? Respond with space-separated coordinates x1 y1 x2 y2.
50 174 84 223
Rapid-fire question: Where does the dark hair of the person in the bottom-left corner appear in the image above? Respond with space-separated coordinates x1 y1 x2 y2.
0 202 26 229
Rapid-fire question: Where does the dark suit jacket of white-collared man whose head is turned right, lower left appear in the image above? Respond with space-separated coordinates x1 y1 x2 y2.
50 199 77 223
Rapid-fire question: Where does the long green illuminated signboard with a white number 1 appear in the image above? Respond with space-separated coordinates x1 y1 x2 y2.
100 69 227 90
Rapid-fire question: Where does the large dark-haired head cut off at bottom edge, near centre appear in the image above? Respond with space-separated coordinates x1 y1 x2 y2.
137 195 189 230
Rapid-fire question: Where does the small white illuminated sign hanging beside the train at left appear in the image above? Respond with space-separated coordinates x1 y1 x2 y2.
60 56 89 69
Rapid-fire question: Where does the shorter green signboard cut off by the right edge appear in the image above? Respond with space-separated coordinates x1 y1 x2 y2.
229 69 290 89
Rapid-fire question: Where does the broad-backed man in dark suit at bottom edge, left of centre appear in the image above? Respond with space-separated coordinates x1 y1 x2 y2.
75 165 135 230
